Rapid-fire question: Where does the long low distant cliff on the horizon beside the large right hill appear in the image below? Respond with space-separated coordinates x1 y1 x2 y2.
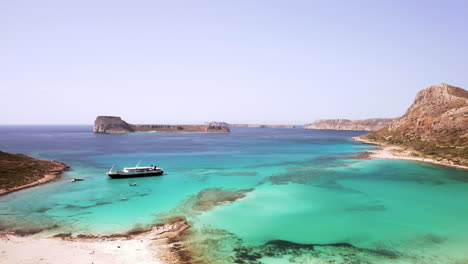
304 118 393 131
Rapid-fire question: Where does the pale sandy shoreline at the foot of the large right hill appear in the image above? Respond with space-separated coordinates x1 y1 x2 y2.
351 137 468 170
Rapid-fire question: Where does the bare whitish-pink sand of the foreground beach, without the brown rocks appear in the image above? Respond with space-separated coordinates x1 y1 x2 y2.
0 235 163 264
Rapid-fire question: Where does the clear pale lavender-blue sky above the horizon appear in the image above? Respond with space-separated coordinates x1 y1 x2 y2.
0 0 468 124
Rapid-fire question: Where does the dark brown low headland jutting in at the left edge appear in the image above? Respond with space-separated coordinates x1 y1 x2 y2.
0 151 69 195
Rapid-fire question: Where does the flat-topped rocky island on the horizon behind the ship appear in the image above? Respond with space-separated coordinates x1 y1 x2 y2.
93 116 230 134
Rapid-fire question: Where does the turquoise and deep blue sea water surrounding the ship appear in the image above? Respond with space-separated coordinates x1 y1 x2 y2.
0 126 468 263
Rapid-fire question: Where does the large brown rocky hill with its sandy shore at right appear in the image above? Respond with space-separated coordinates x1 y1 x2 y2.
354 83 468 169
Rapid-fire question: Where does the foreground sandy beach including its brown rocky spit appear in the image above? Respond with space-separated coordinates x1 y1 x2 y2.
0 219 190 264
